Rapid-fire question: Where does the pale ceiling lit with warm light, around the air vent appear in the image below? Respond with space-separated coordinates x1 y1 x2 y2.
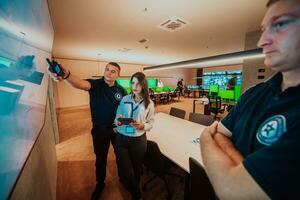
48 0 266 65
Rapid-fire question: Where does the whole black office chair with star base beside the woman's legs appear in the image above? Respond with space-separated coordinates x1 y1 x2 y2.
142 140 183 199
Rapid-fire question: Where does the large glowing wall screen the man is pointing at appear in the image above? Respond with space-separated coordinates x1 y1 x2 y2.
0 0 53 199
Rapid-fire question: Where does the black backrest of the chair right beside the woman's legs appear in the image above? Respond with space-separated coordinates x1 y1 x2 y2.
144 140 166 176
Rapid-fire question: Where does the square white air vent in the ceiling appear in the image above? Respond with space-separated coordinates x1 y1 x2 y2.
158 16 190 32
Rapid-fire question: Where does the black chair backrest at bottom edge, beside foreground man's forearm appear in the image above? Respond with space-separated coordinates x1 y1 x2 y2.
189 158 216 200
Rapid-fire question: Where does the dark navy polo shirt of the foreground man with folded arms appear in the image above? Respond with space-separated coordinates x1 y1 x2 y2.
222 73 300 199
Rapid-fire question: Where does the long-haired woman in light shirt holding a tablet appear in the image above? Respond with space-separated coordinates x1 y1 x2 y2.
115 72 154 199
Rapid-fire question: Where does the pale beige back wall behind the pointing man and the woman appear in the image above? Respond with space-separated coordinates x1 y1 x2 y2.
54 58 196 108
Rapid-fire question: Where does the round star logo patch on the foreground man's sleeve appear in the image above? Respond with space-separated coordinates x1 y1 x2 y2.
256 115 286 146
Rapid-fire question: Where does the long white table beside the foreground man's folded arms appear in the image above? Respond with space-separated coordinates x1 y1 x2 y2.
147 113 206 173
